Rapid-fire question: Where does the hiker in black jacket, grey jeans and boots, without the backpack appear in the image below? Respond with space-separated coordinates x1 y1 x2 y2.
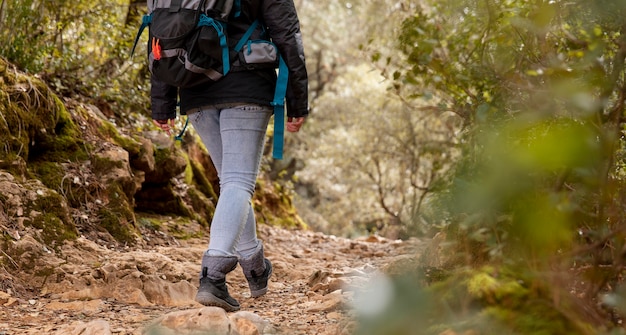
151 0 309 312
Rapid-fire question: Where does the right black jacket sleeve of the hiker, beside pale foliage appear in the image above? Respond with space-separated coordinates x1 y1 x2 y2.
262 0 309 117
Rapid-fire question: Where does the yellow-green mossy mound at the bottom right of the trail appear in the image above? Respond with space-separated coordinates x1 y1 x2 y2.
416 267 591 335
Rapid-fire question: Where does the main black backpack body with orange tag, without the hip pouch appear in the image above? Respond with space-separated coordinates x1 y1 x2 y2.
132 0 257 87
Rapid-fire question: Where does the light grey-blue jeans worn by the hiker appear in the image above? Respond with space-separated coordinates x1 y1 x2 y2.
189 104 272 258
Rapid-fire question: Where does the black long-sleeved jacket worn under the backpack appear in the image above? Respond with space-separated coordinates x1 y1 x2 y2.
151 0 309 120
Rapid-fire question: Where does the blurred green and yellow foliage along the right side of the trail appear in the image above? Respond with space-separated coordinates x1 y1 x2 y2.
356 0 626 334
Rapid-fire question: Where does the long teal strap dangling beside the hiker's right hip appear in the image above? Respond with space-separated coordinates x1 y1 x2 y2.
271 56 289 159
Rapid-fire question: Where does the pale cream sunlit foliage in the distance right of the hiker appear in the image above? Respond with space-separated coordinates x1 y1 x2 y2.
288 0 458 238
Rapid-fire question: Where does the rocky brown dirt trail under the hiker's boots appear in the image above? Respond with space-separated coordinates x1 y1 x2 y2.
0 226 422 335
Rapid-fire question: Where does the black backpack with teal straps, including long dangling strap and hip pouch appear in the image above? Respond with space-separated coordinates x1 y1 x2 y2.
131 0 289 159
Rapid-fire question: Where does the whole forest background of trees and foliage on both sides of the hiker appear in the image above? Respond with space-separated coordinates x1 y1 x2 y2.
0 0 626 334
